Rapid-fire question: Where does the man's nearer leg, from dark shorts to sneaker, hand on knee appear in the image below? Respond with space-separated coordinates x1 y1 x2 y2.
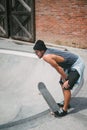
59 70 80 117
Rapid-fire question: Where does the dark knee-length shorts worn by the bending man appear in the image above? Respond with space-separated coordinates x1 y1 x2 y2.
59 70 80 90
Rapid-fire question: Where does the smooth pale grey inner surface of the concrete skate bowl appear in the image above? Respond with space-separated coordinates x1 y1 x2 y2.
0 50 83 128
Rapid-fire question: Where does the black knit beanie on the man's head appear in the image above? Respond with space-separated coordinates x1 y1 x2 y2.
33 40 47 51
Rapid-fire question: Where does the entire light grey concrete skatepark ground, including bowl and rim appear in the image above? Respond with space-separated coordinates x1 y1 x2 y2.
0 39 87 130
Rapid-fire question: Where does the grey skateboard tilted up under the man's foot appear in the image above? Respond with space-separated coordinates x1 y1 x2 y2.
38 82 60 117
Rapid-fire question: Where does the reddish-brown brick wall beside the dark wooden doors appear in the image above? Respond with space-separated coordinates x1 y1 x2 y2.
35 0 87 48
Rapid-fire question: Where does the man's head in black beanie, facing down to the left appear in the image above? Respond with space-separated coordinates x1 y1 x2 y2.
33 40 47 58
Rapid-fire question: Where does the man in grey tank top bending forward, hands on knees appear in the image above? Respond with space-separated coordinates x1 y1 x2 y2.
33 40 84 117
